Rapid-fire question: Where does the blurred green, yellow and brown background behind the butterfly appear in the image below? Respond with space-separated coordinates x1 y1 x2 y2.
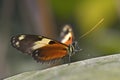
0 0 120 79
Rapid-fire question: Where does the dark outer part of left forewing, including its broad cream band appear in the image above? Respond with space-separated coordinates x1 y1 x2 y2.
11 35 54 55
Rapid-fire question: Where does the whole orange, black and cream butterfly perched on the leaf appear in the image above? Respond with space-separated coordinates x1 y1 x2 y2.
11 25 80 63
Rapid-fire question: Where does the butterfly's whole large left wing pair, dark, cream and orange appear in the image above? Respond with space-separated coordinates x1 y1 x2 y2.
11 35 68 61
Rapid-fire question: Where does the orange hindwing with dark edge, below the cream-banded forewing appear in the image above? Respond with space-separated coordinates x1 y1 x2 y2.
32 42 68 62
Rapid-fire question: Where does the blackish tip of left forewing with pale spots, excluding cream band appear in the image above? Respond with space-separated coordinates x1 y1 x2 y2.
11 34 44 55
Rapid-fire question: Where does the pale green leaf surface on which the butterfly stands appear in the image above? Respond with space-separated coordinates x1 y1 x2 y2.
4 54 120 80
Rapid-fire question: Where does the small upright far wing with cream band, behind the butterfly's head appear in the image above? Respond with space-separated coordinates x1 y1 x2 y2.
60 25 74 45
